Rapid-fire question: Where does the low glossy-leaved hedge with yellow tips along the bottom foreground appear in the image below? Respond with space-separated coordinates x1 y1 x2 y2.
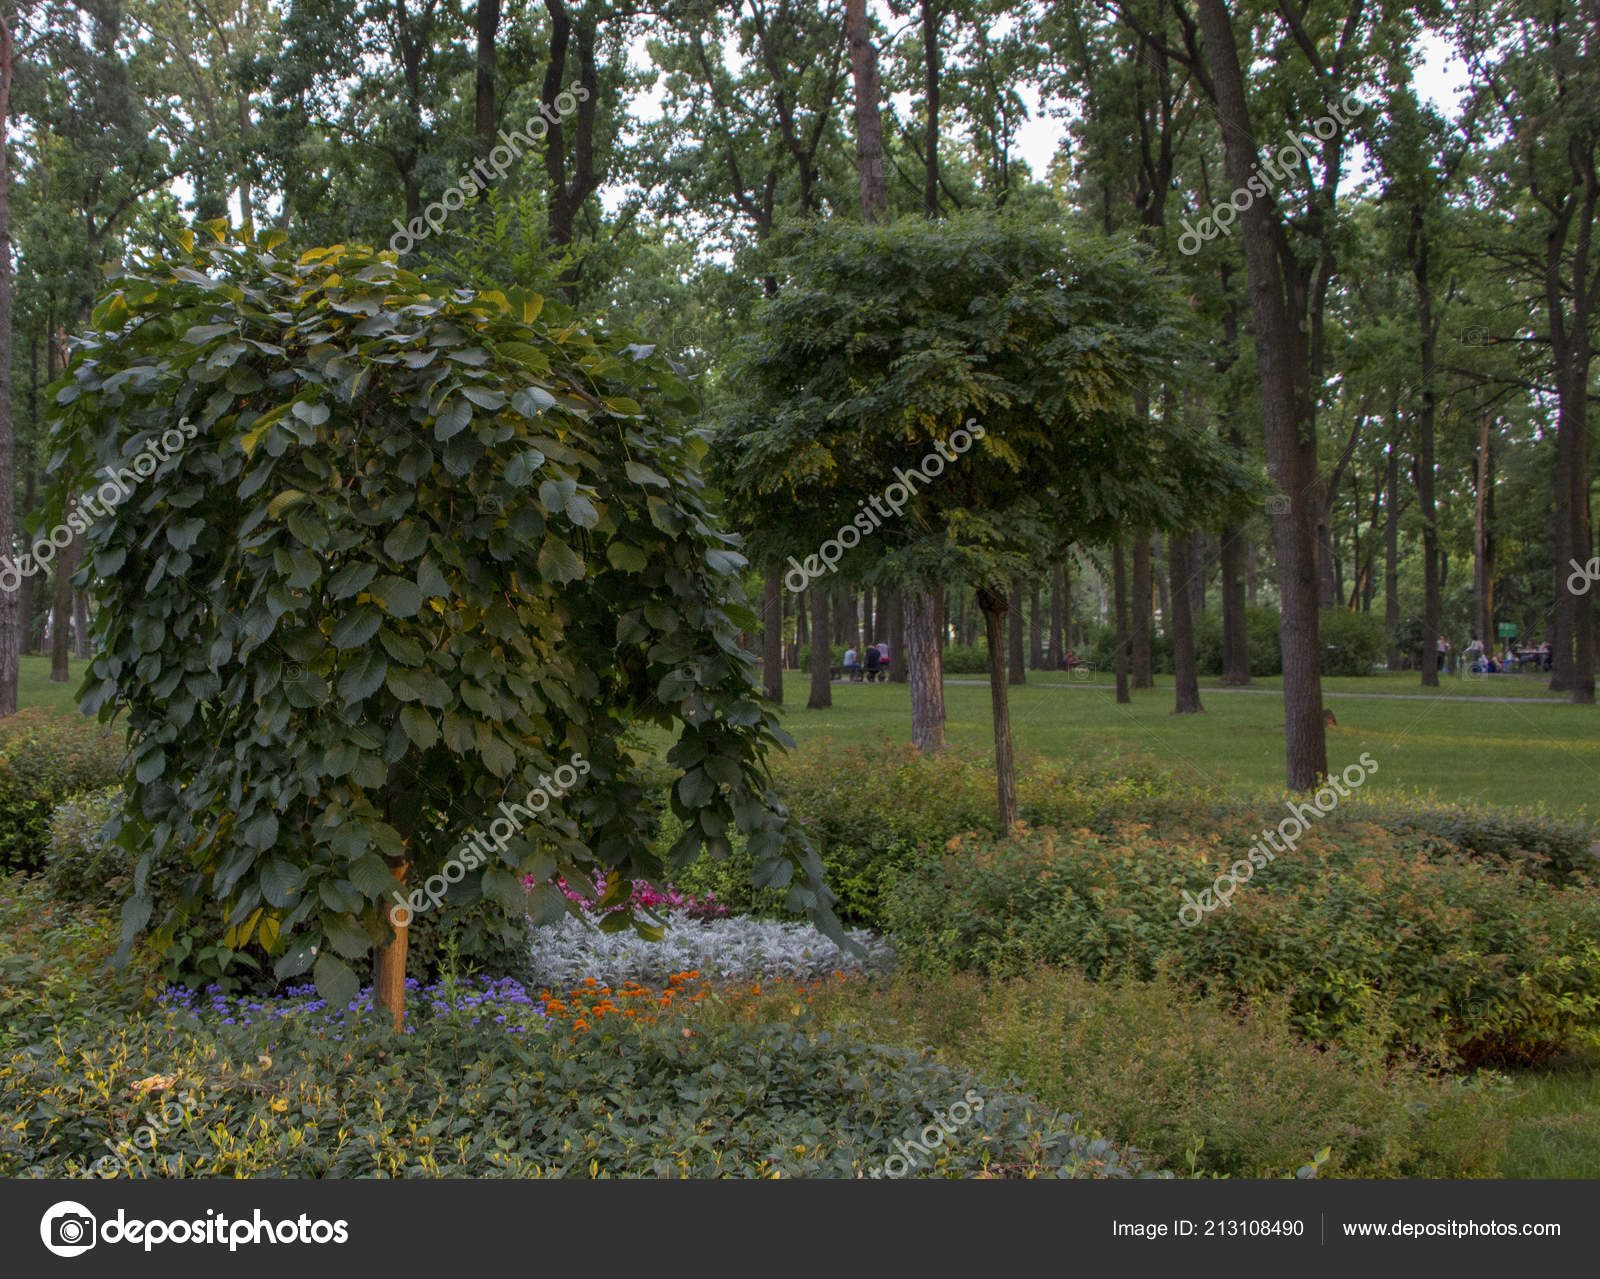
0 1008 1139 1178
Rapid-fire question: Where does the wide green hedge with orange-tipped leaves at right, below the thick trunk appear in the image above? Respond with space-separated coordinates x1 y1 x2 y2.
886 816 1600 1063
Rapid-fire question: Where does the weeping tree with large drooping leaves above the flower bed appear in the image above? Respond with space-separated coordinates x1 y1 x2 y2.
50 224 840 1021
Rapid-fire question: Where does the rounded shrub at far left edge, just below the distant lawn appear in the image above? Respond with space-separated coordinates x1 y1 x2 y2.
0 706 125 874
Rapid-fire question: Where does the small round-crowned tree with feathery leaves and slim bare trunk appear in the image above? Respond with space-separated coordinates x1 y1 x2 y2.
715 213 1256 829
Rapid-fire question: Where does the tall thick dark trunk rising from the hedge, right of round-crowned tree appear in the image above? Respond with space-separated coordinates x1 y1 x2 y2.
1197 0 1328 791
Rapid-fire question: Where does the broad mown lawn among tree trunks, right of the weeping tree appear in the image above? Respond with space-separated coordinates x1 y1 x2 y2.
784 671 1600 816
